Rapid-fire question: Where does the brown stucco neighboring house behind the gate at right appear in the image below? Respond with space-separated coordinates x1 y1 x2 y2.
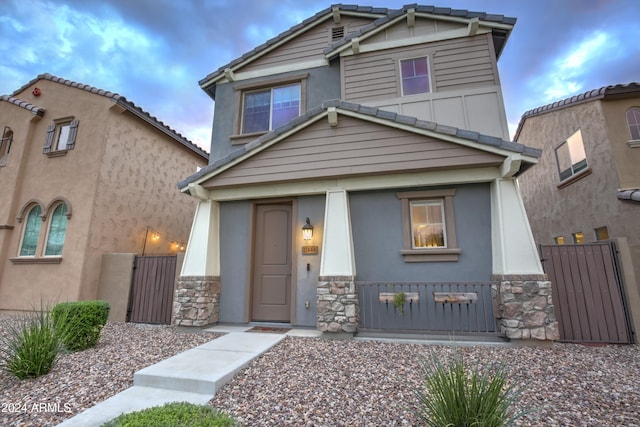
516 83 640 290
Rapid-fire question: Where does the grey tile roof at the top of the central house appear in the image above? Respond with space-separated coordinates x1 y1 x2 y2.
198 3 516 90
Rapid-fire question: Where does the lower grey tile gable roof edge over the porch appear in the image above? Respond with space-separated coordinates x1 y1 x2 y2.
178 100 542 191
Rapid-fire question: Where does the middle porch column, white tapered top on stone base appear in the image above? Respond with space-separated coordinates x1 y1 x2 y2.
316 189 359 333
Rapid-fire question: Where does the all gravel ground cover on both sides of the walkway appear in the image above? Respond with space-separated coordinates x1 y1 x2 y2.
0 319 640 426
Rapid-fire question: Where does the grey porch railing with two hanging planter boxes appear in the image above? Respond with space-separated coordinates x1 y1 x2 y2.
357 282 498 335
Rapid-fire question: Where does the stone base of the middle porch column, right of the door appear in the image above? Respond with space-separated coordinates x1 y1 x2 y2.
316 276 360 333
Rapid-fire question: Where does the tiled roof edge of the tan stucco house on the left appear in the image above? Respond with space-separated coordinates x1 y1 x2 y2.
5 73 209 159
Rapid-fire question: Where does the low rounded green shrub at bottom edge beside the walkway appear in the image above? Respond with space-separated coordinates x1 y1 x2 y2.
102 402 240 427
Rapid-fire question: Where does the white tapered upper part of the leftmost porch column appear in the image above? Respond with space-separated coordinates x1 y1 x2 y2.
180 200 220 276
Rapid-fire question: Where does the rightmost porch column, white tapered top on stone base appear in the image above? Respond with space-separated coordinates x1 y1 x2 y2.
491 178 560 341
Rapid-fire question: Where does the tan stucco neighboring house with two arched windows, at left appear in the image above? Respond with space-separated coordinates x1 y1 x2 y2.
0 74 208 318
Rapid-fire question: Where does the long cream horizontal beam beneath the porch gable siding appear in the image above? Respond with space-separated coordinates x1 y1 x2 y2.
209 167 500 202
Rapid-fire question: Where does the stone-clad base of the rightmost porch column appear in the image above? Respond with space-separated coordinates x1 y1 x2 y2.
491 274 560 341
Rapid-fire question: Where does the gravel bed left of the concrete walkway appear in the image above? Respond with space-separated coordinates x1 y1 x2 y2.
0 316 217 427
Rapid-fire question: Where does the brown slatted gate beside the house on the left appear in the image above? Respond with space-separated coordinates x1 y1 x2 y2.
127 255 177 325
